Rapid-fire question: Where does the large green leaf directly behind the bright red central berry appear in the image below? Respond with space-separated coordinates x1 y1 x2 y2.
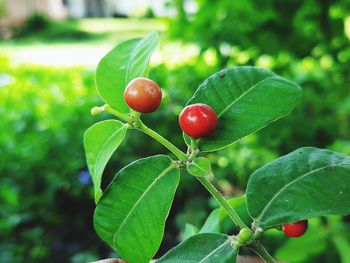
187 67 302 151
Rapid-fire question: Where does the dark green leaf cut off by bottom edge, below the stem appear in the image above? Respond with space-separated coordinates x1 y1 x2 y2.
156 233 237 263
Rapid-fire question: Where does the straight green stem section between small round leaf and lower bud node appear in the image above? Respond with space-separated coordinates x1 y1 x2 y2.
197 177 248 229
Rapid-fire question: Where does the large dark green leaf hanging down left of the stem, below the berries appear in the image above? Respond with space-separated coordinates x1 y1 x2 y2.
94 155 180 263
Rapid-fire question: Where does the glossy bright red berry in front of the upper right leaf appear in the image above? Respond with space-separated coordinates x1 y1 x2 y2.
179 103 218 139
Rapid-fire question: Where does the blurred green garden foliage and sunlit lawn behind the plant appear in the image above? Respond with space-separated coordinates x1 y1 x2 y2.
0 0 350 263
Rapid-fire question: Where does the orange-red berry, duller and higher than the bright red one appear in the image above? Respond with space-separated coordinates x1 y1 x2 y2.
124 78 162 113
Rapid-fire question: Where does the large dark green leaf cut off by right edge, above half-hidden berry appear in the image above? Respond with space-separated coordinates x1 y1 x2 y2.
246 147 350 228
